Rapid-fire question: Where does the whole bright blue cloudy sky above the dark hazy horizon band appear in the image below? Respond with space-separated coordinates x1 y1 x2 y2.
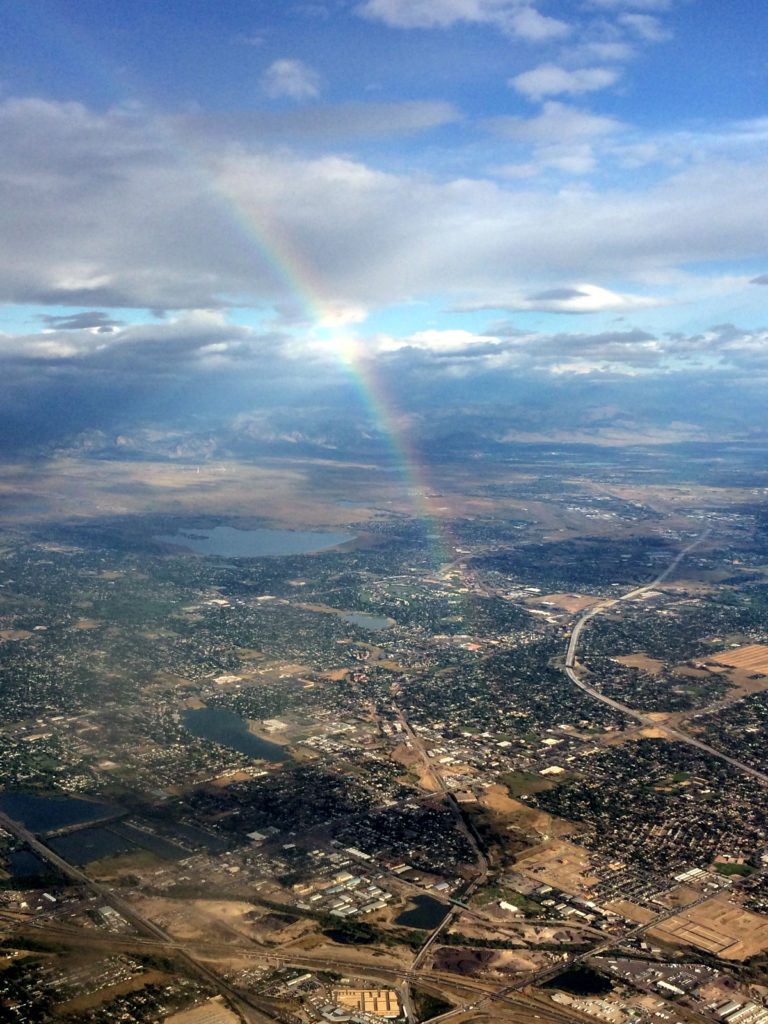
0 0 768 438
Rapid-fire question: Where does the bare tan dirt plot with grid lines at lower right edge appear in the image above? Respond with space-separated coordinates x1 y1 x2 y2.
648 894 768 961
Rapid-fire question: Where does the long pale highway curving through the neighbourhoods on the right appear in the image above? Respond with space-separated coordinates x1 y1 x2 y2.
563 530 768 785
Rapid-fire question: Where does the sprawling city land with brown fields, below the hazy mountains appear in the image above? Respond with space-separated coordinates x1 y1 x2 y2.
0 442 768 1024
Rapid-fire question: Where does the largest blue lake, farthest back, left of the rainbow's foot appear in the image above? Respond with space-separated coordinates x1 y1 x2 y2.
153 526 354 558
